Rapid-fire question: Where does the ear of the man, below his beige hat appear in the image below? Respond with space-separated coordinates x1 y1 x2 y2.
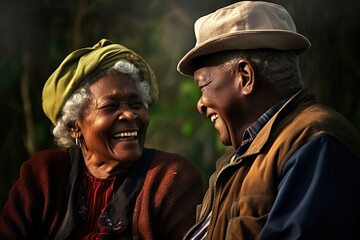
237 58 256 95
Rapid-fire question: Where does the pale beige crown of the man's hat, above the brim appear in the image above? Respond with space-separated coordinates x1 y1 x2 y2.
194 1 296 45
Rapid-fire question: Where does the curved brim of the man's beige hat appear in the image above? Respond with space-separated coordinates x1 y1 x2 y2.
177 29 311 76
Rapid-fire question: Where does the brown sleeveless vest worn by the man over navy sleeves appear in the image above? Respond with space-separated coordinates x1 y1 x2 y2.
184 90 360 240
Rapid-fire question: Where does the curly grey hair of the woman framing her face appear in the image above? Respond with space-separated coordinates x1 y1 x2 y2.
52 60 151 147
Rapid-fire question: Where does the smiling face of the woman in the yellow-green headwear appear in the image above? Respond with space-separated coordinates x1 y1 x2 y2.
78 73 149 165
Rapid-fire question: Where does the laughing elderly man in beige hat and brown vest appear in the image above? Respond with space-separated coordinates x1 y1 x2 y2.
178 1 360 239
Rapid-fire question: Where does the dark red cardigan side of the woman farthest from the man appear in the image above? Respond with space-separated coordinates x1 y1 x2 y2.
0 150 67 240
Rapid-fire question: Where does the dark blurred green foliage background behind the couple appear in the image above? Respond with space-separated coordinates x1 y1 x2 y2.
0 0 360 208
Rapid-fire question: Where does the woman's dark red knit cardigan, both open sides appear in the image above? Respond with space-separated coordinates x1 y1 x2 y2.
0 149 204 240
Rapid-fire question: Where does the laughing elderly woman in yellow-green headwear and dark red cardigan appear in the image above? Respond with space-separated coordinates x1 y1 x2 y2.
0 39 203 240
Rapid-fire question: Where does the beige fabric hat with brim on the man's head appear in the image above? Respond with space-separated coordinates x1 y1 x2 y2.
177 1 311 76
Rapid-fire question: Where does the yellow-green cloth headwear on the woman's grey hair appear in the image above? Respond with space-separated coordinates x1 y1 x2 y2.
42 39 158 125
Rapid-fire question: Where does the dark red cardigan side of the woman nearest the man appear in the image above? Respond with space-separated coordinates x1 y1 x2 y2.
135 152 204 240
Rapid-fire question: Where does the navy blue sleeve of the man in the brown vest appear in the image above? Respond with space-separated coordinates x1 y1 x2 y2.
260 135 360 239
